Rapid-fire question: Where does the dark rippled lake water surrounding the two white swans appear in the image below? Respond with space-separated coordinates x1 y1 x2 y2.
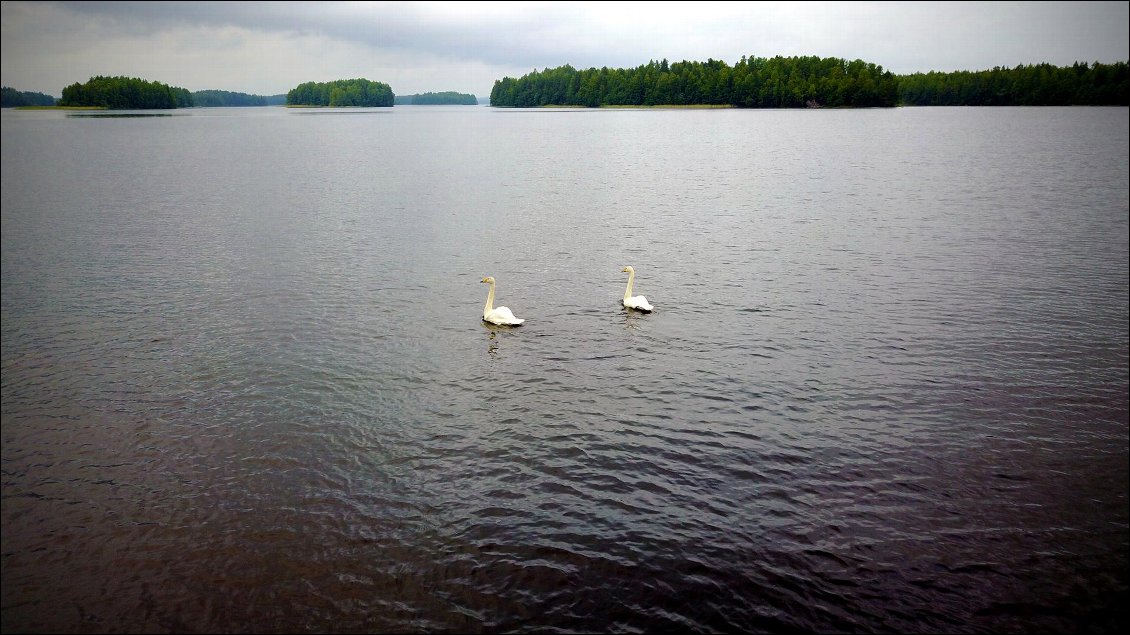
2 106 1130 633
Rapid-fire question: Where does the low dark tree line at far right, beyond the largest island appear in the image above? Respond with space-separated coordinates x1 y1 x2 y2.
898 62 1130 106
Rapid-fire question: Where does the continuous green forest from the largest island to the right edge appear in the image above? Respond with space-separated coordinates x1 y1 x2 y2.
490 56 1128 108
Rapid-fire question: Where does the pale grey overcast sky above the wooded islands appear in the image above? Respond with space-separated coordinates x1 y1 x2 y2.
0 0 1130 97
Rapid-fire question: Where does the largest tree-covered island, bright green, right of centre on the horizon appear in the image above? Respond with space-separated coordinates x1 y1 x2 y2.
490 56 898 108
